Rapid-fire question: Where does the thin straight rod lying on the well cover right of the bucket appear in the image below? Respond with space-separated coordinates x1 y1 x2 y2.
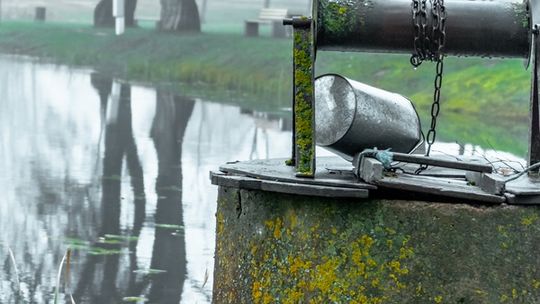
392 153 493 173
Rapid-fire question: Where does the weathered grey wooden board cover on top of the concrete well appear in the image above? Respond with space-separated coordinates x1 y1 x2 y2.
212 157 540 204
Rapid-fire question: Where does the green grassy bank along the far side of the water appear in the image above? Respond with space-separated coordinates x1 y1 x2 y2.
0 22 529 155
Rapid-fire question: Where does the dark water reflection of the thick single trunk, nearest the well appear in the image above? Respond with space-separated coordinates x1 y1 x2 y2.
149 92 195 303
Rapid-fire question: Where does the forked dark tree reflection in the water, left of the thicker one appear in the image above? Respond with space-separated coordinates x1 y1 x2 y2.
74 73 146 303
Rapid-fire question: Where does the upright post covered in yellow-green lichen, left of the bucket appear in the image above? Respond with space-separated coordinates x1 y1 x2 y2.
284 17 315 177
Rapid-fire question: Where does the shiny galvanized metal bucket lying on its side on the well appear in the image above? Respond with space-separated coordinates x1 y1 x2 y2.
315 74 422 161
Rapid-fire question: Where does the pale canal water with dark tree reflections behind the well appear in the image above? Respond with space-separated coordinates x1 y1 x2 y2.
0 57 519 304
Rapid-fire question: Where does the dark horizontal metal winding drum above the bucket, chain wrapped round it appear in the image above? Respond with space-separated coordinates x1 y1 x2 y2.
313 0 530 58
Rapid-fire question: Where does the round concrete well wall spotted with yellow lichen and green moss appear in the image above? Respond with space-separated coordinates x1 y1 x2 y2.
214 187 540 303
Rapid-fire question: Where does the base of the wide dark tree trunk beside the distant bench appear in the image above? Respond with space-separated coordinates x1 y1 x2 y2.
160 0 201 32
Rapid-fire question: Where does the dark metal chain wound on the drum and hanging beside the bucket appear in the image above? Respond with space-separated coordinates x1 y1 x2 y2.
411 0 446 174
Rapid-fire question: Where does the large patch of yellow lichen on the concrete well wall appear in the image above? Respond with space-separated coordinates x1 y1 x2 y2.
250 213 414 303
